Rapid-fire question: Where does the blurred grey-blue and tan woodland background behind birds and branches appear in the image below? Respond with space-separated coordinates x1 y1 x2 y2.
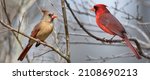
0 0 150 63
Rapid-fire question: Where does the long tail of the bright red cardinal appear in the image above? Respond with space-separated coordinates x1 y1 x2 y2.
123 35 141 59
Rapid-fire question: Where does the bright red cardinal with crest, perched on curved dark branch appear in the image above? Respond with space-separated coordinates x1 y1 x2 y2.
91 4 141 59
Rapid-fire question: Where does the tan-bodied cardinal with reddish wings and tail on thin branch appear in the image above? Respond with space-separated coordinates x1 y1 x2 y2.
18 10 57 61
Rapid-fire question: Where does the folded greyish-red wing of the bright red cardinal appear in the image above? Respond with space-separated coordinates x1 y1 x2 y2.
99 13 126 36
